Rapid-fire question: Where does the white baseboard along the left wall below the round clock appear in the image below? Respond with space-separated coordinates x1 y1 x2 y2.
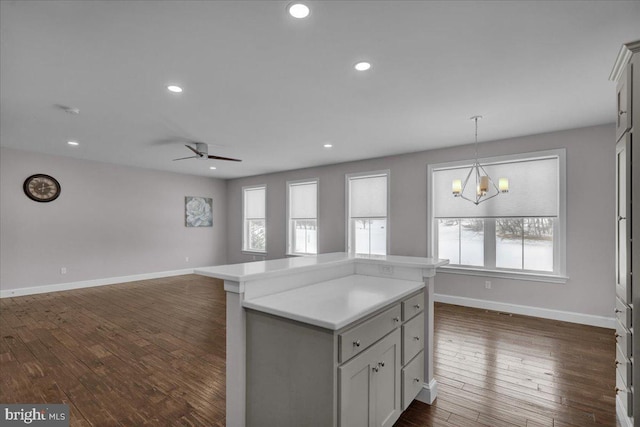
0 268 193 298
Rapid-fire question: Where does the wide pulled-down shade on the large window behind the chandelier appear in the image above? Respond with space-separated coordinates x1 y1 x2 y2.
432 156 559 218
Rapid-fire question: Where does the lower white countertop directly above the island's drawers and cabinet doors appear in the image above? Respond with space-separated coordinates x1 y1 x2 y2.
242 274 424 330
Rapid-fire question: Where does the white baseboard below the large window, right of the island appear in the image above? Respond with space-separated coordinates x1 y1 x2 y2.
434 294 616 329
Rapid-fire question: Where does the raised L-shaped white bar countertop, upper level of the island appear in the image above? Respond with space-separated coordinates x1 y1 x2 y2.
195 252 449 282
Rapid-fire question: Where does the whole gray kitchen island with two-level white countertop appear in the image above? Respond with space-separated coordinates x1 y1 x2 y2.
196 253 447 427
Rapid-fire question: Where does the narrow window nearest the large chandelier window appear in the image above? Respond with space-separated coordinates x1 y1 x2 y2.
347 171 389 255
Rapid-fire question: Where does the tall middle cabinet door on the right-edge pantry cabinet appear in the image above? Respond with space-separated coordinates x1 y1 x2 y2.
616 137 632 304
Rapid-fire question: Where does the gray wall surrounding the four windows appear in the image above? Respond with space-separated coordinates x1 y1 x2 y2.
227 125 615 317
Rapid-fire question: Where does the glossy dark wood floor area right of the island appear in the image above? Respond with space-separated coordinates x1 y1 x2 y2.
396 304 616 427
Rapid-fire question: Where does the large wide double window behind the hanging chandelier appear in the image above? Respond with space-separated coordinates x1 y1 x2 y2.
428 150 566 281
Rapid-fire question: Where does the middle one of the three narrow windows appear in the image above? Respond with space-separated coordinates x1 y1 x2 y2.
287 179 318 255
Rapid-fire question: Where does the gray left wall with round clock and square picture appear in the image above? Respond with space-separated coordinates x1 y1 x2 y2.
0 148 226 290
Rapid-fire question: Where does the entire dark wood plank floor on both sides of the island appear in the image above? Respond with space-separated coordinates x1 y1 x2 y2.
0 275 615 427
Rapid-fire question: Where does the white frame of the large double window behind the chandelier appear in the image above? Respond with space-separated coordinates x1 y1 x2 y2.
427 148 569 283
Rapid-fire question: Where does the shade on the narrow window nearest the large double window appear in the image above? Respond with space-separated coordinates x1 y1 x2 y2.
349 175 387 218
